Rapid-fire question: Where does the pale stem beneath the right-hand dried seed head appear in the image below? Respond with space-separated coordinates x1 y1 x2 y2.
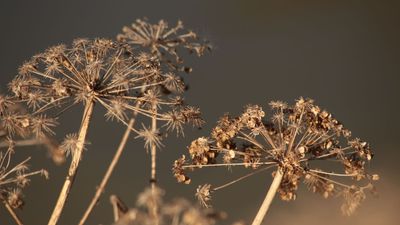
252 168 283 225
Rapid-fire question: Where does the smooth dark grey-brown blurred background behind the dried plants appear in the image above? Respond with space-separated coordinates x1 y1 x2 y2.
0 0 400 225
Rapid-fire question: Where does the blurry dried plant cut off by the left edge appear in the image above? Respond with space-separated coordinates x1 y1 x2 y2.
0 92 50 224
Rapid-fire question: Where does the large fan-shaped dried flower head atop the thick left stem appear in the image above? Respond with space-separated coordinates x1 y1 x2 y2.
10 39 159 124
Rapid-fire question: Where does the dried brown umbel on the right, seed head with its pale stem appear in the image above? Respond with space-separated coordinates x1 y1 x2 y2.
173 98 379 225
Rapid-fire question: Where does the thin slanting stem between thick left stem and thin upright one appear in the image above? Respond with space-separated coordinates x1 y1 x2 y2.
79 117 137 225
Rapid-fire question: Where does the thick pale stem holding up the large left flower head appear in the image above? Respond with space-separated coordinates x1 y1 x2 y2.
48 99 94 225
